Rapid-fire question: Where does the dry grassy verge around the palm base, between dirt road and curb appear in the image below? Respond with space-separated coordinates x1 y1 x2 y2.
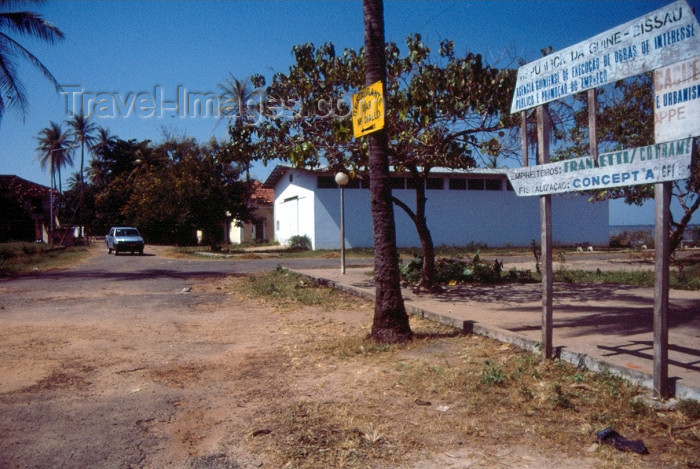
227 269 700 468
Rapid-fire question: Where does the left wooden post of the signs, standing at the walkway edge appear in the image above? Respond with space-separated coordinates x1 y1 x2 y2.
537 105 554 359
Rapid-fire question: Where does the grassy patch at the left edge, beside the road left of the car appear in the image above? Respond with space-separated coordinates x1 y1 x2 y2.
0 242 90 277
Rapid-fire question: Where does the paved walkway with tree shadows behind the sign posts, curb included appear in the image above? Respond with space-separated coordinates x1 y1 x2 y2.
297 267 700 400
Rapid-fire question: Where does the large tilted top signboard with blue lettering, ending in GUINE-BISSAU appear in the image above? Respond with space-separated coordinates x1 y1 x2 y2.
510 0 700 113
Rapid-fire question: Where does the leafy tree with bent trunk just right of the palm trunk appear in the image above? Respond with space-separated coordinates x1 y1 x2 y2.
387 34 516 291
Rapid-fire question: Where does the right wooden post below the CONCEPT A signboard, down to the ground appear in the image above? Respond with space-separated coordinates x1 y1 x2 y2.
654 182 672 399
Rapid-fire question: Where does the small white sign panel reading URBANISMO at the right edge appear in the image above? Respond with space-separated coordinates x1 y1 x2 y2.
654 54 700 142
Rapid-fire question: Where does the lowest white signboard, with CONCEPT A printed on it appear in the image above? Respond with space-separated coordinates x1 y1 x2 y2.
506 138 693 196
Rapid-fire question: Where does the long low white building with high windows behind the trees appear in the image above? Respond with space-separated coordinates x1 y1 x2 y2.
263 166 609 249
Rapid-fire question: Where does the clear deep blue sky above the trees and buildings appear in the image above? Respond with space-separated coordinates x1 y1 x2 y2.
0 0 700 224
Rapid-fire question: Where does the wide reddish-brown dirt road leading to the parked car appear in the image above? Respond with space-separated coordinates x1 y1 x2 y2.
0 248 367 468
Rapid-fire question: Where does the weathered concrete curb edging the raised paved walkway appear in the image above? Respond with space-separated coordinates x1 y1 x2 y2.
290 270 700 401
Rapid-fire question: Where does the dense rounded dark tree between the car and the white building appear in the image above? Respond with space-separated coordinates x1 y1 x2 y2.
119 138 250 245
